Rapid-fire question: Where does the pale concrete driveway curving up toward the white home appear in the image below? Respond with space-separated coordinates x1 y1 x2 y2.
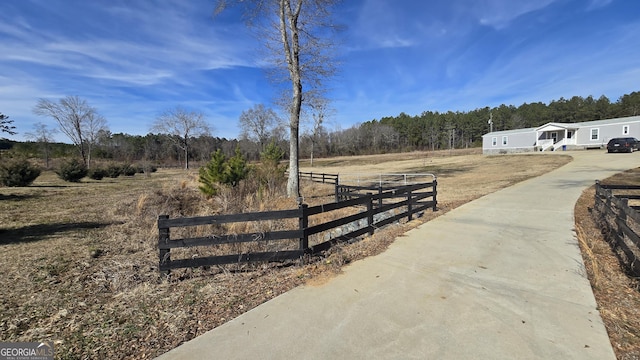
160 151 640 360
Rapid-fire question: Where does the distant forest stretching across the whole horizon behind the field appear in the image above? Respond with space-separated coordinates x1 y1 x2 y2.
0 92 640 166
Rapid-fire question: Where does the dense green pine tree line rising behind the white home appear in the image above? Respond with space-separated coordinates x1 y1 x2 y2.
328 92 640 155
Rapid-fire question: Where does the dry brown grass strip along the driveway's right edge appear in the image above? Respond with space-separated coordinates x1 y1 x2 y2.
575 169 640 360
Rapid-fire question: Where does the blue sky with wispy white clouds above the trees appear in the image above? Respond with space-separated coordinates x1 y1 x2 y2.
0 0 640 140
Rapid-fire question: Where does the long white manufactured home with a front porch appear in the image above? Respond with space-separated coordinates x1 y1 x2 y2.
482 116 640 154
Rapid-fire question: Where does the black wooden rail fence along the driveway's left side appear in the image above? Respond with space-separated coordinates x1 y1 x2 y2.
158 180 437 273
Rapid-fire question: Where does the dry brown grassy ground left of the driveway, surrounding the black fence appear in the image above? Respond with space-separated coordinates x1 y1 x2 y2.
0 150 640 359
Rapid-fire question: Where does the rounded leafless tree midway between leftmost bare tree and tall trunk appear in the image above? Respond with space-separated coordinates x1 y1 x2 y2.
151 106 210 169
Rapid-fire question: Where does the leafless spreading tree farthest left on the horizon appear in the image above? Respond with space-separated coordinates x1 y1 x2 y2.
33 96 100 167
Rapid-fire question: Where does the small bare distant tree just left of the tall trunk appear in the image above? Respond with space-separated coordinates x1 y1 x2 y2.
240 104 278 151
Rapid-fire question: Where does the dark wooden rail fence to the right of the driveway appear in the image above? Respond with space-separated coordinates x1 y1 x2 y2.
594 181 640 276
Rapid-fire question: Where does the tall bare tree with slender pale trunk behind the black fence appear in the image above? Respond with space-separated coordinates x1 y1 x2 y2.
216 0 340 197
